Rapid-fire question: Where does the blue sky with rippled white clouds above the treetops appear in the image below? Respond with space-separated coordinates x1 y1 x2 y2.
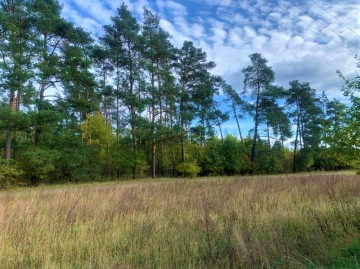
59 0 360 137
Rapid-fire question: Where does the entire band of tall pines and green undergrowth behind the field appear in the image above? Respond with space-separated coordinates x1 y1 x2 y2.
0 0 360 187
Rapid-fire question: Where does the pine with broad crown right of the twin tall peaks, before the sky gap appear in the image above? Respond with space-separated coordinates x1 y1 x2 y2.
174 41 218 162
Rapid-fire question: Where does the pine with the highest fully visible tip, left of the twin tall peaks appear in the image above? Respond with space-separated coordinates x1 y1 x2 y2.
102 4 144 178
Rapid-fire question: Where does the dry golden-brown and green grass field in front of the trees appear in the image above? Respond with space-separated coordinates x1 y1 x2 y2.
0 174 360 268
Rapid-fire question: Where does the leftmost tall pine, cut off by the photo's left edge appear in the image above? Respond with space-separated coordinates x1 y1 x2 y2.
0 0 35 162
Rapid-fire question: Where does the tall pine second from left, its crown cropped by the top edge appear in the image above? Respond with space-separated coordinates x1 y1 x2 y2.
28 0 75 145
